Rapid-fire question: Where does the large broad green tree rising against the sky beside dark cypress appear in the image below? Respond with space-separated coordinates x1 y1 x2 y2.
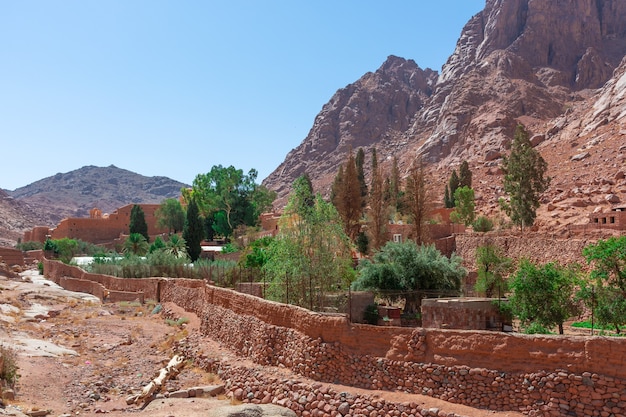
183 165 276 237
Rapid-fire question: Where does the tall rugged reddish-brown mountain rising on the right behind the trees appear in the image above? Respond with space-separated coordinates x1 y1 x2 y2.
264 0 626 231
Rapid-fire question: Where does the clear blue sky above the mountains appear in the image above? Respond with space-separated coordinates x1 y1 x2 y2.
0 0 485 190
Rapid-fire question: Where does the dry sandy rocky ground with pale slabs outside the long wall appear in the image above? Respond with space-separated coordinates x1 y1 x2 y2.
0 271 520 417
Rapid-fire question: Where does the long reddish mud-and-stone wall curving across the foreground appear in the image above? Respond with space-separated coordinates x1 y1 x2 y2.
45 261 626 416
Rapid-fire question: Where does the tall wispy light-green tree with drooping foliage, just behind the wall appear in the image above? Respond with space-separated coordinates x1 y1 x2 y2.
263 176 354 308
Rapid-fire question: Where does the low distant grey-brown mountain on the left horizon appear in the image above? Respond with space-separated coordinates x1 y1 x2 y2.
0 165 188 244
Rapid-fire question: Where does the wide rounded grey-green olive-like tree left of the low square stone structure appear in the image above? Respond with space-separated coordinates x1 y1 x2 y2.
352 240 467 313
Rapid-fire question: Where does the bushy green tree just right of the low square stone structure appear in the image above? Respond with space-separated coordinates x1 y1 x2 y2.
509 259 580 334
